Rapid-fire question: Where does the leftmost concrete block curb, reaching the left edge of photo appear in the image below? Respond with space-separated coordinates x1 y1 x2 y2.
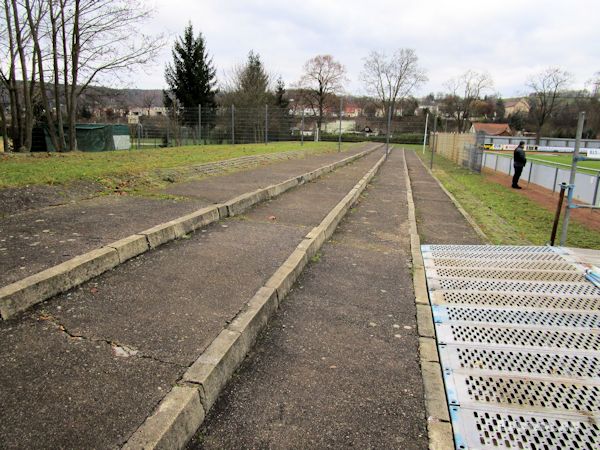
0 145 382 320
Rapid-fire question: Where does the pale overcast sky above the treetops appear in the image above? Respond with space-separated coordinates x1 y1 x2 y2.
130 0 600 97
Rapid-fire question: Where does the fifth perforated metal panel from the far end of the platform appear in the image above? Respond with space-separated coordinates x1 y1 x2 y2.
430 291 600 311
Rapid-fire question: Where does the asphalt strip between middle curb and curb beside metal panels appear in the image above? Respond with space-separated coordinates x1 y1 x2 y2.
189 150 428 449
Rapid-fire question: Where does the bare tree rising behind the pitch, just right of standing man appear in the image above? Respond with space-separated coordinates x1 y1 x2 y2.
527 67 572 144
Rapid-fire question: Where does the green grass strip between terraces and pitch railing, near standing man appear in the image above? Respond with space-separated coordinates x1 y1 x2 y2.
416 150 600 249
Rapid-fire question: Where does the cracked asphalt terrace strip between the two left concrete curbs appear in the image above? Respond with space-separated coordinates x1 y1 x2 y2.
0 148 382 448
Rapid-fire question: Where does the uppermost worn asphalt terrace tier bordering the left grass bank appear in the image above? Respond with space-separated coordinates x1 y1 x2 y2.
0 144 374 287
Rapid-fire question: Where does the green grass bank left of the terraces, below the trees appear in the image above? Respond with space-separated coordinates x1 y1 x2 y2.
0 142 360 188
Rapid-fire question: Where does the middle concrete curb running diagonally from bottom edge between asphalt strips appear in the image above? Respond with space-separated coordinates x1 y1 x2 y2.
123 150 385 449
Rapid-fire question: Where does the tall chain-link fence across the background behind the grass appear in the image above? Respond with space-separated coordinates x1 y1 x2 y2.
99 103 425 148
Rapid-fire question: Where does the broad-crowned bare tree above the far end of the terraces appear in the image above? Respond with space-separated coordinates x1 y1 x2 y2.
361 48 427 116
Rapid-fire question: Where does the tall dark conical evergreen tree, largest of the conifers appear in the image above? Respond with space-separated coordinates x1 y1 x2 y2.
165 23 216 112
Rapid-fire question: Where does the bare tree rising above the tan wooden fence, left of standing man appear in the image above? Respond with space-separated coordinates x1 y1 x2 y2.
441 70 494 133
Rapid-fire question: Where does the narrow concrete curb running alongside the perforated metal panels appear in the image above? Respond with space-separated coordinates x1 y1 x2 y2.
404 150 454 450
